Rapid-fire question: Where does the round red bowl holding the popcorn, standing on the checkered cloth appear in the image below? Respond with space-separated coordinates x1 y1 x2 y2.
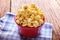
14 16 45 37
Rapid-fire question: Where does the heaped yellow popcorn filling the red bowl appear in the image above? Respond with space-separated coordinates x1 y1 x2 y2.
16 4 44 27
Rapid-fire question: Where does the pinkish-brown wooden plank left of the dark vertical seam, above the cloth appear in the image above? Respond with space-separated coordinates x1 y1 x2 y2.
0 0 10 17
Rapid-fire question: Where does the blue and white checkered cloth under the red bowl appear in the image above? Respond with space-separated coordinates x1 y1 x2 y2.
0 12 52 40
